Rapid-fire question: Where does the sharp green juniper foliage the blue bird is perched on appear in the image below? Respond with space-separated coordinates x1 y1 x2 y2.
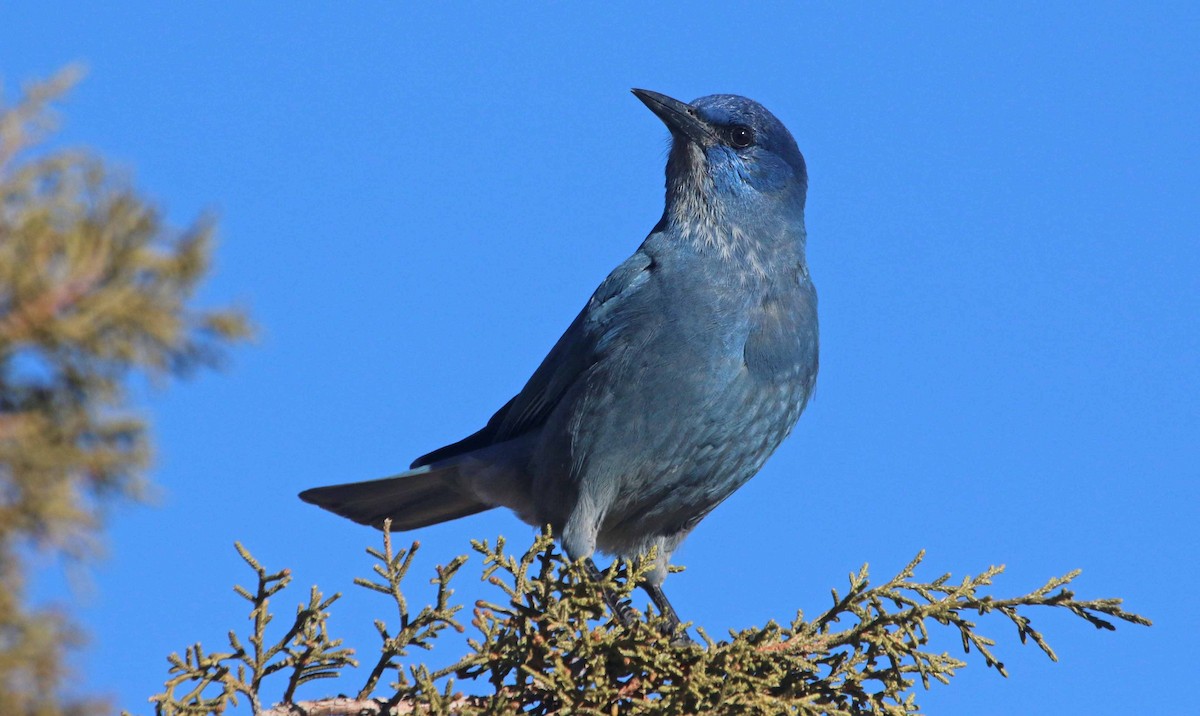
151 522 1150 716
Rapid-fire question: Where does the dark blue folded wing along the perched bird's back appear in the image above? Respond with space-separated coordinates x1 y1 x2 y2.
413 251 654 468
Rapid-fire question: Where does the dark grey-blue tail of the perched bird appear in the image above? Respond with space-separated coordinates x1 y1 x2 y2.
300 464 494 531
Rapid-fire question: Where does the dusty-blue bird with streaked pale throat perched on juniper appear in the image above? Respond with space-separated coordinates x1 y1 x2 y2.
300 89 817 628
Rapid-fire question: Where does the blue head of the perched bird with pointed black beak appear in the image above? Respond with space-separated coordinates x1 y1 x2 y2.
634 90 809 229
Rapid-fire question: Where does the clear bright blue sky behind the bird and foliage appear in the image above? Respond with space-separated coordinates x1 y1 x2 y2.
0 2 1200 715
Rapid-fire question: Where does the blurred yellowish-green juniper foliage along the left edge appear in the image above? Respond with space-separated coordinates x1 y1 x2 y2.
0 71 247 716
